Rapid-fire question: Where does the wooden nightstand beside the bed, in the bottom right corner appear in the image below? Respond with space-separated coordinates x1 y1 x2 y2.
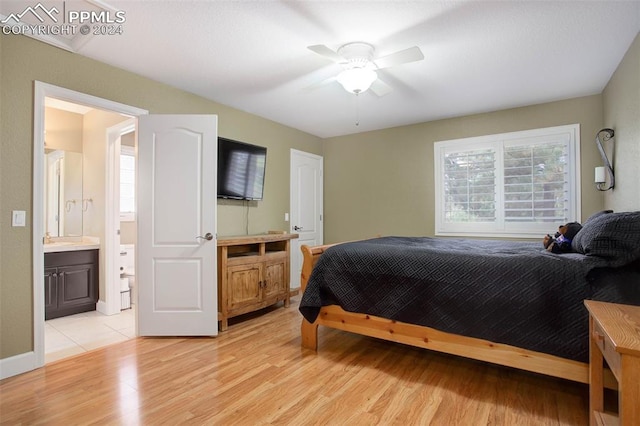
584 300 640 426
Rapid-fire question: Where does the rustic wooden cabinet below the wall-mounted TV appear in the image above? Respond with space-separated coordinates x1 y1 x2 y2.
217 233 298 331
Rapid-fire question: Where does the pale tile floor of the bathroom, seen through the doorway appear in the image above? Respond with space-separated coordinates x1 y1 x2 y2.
44 305 136 363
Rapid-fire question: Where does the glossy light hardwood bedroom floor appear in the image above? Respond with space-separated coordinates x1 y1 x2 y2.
0 297 588 426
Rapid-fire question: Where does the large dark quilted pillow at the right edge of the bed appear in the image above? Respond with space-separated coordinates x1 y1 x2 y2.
571 211 640 267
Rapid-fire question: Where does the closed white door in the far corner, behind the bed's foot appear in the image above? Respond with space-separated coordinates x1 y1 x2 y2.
289 149 323 289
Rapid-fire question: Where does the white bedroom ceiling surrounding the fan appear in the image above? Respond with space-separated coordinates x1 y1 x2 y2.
0 0 640 138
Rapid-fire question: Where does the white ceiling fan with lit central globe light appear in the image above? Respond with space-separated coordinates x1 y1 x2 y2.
308 41 424 96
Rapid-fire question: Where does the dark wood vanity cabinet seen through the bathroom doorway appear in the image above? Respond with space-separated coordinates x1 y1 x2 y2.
44 250 98 320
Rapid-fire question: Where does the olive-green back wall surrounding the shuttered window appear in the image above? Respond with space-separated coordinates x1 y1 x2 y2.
324 95 603 243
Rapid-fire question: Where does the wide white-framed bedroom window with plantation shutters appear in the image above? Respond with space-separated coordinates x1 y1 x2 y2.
434 124 580 237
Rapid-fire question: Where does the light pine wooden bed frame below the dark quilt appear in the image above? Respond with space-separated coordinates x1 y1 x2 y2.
301 244 596 389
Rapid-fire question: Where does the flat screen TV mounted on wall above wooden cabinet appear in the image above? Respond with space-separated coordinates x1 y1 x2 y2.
218 138 267 200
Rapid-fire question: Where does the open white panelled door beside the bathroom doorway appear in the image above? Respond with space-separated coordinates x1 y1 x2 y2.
136 115 218 336
